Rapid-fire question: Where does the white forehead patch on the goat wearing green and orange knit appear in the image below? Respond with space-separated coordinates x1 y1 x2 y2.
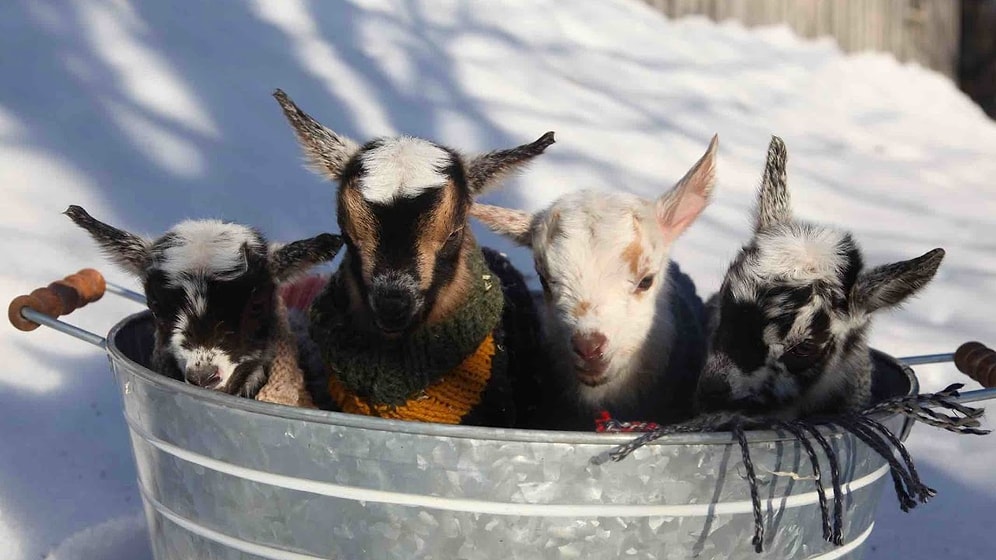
359 136 450 204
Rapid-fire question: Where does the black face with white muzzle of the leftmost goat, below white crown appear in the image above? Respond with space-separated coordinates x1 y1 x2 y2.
145 247 277 396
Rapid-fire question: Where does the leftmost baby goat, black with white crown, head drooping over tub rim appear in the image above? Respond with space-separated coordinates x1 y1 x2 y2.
66 206 342 406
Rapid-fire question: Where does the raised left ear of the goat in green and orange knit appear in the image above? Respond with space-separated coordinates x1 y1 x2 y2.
273 89 359 181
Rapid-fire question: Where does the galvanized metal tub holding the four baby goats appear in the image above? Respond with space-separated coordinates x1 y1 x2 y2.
107 313 918 560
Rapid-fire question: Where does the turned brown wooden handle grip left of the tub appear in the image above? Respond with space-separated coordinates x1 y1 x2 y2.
7 268 107 331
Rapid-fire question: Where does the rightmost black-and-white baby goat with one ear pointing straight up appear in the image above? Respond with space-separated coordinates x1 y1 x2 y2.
697 137 944 418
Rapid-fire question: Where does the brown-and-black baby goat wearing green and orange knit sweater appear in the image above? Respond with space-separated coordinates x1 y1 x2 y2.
274 90 554 426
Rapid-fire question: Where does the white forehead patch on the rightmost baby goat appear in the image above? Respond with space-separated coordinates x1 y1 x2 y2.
751 227 846 282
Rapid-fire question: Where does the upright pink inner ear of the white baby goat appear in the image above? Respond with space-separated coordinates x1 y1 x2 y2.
655 135 719 242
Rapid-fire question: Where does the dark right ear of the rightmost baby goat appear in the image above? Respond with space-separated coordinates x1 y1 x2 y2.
851 249 944 313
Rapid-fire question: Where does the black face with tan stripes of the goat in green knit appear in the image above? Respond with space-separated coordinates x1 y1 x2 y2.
338 144 471 335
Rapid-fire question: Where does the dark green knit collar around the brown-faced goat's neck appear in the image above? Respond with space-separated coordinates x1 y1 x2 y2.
310 247 505 405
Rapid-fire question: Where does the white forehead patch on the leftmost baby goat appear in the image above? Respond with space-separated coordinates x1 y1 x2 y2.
159 220 260 284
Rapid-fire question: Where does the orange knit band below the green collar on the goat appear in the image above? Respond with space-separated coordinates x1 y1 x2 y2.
329 334 495 424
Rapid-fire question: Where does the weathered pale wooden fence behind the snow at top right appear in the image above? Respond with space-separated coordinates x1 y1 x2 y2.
643 0 961 77
